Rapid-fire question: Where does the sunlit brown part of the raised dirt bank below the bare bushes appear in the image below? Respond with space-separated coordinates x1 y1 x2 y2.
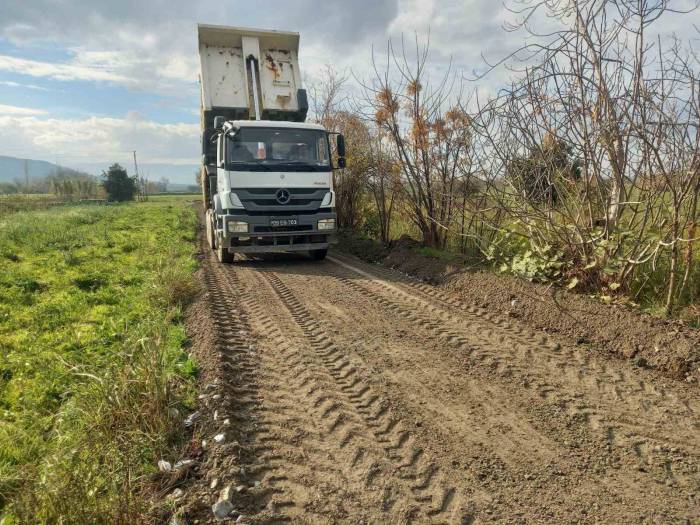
441 271 700 379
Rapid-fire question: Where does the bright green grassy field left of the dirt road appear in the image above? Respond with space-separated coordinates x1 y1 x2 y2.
0 195 202 524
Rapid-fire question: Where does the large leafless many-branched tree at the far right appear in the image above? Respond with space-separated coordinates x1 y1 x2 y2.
475 0 698 313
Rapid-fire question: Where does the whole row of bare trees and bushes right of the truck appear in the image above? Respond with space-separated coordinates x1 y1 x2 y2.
310 0 700 315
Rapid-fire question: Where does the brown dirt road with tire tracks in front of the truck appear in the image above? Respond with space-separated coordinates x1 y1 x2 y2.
186 246 700 524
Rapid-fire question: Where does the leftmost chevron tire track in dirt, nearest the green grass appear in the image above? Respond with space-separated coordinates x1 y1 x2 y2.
205 261 318 523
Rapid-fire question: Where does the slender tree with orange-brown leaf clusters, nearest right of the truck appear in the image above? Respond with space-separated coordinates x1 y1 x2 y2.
361 35 470 248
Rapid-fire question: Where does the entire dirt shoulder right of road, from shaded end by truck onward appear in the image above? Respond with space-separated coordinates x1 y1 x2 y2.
336 233 700 384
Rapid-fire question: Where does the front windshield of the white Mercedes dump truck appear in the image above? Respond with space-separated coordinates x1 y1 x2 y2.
226 127 331 171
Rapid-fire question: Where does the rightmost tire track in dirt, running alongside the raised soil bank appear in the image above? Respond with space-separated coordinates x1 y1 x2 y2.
332 259 700 456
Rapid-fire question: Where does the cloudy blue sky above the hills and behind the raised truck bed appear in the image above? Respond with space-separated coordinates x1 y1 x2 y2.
0 0 700 183
